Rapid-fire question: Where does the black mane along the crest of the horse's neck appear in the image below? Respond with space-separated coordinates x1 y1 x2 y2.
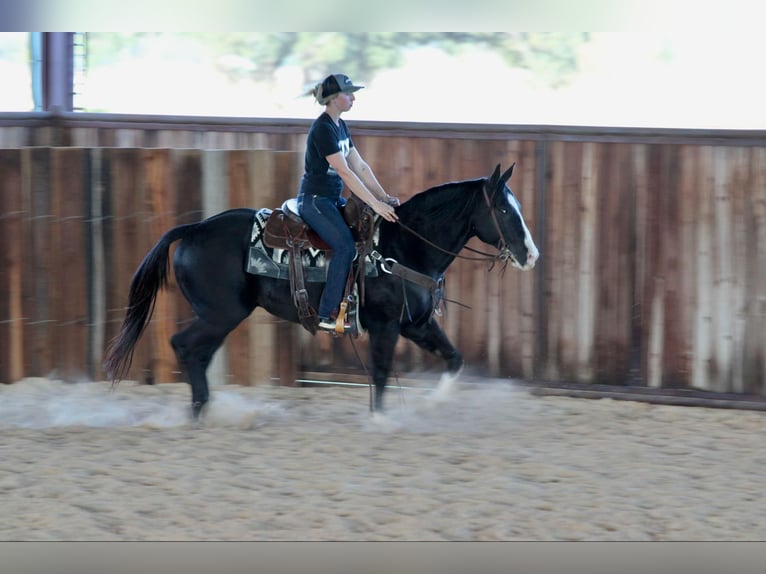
397 179 483 222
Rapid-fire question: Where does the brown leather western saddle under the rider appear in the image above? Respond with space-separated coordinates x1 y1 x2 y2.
263 195 375 337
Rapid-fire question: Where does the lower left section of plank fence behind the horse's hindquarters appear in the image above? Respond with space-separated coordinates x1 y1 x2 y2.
0 148 300 390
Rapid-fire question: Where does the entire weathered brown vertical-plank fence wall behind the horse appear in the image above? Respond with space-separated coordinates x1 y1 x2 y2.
0 120 766 394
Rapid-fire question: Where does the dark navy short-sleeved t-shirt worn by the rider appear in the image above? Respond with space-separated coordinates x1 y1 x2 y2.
298 112 354 199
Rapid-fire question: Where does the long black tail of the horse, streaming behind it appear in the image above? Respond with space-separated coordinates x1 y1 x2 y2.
104 223 197 384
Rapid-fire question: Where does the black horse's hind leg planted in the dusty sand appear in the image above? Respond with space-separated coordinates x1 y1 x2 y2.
170 319 231 420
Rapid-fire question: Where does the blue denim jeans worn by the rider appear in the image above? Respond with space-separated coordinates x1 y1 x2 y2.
298 195 356 320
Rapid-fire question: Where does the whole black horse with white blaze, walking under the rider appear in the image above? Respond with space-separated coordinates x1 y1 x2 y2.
104 164 539 418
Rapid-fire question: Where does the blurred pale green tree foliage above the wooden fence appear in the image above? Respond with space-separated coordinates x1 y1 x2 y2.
87 32 590 88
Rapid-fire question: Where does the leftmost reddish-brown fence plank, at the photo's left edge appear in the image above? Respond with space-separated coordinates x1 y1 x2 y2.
0 150 26 383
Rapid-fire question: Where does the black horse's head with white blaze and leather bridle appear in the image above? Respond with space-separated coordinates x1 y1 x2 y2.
474 163 540 269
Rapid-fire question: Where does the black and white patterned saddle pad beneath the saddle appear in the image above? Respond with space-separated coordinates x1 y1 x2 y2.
245 212 378 283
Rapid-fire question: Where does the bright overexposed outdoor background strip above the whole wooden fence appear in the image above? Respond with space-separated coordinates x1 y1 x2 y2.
0 29 766 129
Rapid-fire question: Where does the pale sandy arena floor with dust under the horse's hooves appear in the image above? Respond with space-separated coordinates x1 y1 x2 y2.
0 379 766 541
